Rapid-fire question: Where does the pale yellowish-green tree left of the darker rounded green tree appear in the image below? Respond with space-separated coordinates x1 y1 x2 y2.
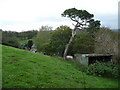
33 26 52 52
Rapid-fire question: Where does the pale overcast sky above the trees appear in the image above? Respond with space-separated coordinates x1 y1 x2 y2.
0 0 119 32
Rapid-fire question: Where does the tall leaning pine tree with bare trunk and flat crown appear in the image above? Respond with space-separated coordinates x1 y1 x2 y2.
62 8 100 59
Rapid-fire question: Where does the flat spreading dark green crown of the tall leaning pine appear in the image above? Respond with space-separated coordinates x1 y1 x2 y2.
62 8 100 29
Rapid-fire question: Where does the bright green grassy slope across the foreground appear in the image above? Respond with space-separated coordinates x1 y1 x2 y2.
2 46 118 88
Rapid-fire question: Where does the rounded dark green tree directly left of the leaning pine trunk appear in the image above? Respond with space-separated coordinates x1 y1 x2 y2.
46 26 72 56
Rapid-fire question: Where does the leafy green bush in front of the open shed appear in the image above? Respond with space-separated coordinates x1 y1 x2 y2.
86 62 120 77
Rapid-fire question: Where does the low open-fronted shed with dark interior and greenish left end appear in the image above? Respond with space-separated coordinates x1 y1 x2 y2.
74 54 113 65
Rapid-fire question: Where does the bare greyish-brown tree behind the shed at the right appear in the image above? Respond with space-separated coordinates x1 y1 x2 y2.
95 28 119 63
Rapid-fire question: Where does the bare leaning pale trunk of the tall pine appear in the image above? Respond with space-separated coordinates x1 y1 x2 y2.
63 29 76 60
